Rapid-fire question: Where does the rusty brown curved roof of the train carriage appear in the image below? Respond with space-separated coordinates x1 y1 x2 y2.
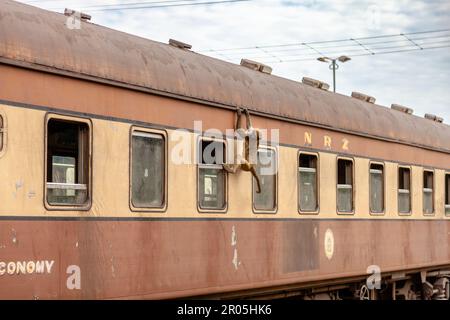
0 0 450 152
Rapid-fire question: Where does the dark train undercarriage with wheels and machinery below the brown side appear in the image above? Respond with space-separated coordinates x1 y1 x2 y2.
195 266 450 300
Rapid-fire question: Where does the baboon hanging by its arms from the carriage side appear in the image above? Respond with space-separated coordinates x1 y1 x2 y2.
223 108 261 193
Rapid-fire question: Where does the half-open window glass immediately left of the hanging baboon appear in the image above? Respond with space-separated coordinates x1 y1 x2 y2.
198 139 226 211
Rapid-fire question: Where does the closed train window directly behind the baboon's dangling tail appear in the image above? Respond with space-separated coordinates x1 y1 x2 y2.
252 148 278 213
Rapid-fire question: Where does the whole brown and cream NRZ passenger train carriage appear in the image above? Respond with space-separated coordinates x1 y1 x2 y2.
0 0 450 299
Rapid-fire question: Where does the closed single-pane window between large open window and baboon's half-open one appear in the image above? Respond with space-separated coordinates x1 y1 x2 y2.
131 130 166 209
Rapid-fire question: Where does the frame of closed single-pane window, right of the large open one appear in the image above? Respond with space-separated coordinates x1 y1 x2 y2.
128 125 169 213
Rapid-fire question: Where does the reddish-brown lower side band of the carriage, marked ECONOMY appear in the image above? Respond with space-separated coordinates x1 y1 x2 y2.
0 220 450 299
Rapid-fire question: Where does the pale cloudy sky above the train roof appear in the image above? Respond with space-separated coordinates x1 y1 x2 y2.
17 0 450 123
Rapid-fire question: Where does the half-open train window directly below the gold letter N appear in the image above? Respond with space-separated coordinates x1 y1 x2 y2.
298 153 319 212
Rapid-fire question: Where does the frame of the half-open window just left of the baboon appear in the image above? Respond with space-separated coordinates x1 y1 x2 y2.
195 135 228 214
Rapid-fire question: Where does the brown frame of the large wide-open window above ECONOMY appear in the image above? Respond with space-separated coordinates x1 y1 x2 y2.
43 113 93 211
